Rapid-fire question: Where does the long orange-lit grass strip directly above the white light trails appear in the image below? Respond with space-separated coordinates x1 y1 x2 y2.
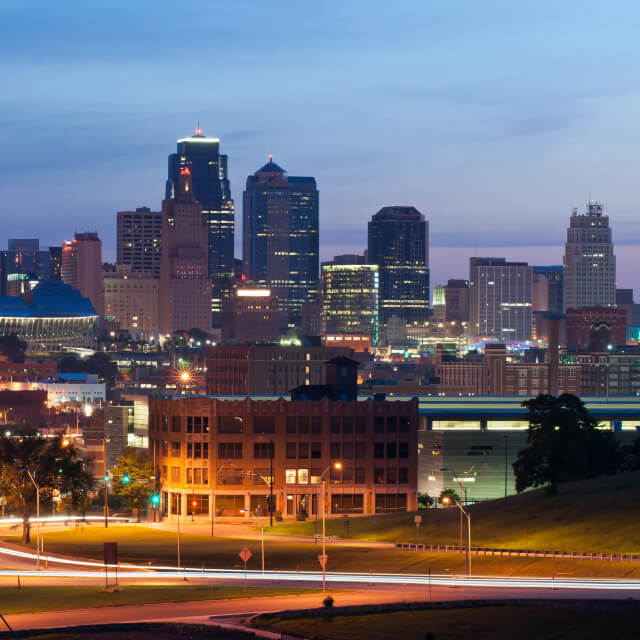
0 525 640 578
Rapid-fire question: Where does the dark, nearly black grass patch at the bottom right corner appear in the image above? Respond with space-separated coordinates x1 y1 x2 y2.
254 606 638 640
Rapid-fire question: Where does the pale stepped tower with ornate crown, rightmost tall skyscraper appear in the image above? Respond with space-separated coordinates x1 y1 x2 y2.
563 200 616 311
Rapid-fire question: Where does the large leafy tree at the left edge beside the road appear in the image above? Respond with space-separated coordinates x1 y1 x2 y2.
0 433 93 544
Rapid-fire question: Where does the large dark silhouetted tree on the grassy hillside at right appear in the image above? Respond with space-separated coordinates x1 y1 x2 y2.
513 393 620 494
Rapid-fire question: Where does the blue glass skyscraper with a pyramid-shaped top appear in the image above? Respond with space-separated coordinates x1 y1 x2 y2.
242 157 319 328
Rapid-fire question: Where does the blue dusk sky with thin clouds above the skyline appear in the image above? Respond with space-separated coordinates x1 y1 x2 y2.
0 0 640 287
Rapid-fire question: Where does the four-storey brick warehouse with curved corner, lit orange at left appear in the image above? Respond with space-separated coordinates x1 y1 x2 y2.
149 396 418 519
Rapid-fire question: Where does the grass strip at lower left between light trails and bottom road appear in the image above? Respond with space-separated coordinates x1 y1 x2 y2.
0 583 316 615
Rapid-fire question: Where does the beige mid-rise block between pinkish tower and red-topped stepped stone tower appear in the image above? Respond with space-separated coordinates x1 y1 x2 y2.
103 264 159 340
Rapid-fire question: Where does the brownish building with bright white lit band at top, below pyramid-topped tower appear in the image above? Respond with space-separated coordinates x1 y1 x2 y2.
222 282 279 344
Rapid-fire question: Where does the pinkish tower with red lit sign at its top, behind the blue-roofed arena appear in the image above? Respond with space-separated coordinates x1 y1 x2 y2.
60 232 104 316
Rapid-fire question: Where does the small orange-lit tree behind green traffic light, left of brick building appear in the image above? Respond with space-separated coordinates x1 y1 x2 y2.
111 449 154 519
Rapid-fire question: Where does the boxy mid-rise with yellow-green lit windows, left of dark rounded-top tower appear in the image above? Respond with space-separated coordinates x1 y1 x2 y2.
322 264 379 344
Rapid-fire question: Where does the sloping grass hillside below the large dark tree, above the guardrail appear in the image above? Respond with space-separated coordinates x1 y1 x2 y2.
274 472 640 554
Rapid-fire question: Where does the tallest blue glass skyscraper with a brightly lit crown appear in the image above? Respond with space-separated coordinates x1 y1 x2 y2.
165 127 234 327
